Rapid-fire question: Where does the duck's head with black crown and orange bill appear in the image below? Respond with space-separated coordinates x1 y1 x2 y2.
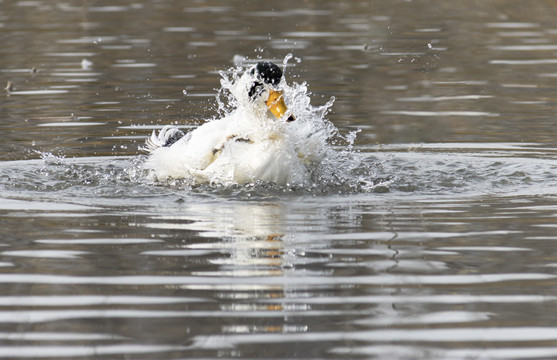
246 61 294 122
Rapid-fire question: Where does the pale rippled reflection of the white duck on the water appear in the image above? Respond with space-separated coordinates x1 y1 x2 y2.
146 201 320 342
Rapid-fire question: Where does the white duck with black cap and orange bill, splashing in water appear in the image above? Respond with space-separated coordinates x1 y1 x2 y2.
144 61 318 185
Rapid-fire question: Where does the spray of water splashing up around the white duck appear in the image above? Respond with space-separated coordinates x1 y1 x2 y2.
143 54 380 192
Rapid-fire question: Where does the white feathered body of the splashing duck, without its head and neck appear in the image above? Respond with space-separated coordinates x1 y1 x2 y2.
144 112 309 185
